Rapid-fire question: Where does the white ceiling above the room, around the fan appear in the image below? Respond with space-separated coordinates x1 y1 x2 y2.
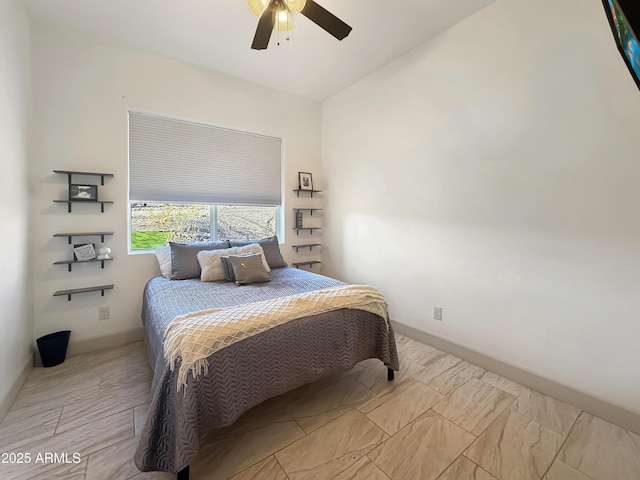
25 0 493 100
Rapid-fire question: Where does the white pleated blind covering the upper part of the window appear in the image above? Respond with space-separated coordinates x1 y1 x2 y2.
129 112 282 206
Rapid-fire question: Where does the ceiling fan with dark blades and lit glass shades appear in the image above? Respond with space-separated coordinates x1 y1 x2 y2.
247 0 351 50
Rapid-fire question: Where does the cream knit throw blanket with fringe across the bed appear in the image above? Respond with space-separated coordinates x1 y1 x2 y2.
164 285 387 391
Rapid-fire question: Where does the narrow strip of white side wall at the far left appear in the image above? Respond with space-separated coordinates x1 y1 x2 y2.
0 0 33 404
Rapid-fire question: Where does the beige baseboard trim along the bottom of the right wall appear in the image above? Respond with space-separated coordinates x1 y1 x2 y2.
391 320 640 435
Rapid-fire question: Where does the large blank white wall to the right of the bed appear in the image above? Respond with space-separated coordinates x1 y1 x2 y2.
322 0 640 412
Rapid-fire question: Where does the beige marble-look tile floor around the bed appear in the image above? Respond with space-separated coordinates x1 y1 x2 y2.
0 335 640 480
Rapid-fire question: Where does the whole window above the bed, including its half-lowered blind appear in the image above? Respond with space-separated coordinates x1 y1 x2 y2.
129 112 282 251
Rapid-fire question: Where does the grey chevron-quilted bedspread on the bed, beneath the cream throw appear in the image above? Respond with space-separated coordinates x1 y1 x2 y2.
134 267 399 479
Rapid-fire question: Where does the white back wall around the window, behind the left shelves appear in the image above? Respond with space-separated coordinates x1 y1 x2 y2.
31 21 320 343
